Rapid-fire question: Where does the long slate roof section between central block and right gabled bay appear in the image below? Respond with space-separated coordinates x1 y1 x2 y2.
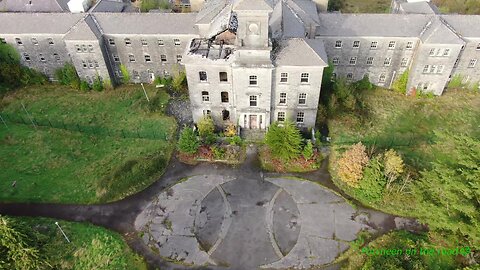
316 13 432 37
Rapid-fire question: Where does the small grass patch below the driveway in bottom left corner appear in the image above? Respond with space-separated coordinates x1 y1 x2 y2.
1 217 147 270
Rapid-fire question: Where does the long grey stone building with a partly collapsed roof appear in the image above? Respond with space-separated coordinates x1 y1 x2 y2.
0 0 480 129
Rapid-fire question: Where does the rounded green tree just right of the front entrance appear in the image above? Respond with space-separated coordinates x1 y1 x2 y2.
265 120 302 161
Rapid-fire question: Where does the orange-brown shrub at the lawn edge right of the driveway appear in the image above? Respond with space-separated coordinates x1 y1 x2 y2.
337 142 369 187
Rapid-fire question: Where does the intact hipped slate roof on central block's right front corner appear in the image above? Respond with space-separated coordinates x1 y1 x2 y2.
274 38 328 67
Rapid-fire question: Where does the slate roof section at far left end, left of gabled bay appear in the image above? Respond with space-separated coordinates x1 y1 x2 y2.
0 13 85 34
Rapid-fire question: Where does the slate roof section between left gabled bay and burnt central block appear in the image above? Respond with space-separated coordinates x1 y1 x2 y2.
93 12 197 35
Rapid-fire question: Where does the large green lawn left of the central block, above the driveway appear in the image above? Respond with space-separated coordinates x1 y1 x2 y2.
0 85 176 203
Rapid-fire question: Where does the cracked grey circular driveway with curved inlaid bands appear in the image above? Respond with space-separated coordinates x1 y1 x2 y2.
135 175 367 269
